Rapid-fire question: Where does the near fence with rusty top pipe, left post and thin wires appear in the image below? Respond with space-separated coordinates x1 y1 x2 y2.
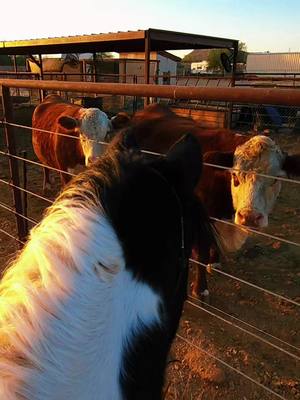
0 80 300 399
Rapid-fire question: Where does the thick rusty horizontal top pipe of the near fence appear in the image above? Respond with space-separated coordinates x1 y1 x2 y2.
0 79 300 106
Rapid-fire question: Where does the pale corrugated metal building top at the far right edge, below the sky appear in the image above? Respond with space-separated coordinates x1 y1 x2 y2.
246 53 300 73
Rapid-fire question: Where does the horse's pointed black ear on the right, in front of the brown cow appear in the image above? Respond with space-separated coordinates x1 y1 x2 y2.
166 134 202 191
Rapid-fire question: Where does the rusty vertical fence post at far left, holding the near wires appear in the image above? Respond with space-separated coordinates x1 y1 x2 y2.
1 86 27 241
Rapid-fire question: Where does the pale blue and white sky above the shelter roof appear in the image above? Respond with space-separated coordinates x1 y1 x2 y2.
0 0 300 55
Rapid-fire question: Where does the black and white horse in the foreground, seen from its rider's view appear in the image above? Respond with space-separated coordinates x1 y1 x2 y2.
0 130 214 400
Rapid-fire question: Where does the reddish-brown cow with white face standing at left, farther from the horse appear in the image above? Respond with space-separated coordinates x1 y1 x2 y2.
32 95 111 189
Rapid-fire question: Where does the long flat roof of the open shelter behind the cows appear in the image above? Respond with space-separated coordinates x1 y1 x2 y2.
0 28 238 55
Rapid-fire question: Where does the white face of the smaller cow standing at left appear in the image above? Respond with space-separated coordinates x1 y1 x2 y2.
78 108 111 165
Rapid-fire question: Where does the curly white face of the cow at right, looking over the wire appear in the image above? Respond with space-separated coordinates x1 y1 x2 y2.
231 135 286 228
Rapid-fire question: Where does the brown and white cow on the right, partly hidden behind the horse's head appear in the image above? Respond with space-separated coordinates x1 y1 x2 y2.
112 105 300 296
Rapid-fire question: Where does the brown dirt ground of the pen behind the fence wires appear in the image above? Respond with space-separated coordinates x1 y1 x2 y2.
0 108 300 400
